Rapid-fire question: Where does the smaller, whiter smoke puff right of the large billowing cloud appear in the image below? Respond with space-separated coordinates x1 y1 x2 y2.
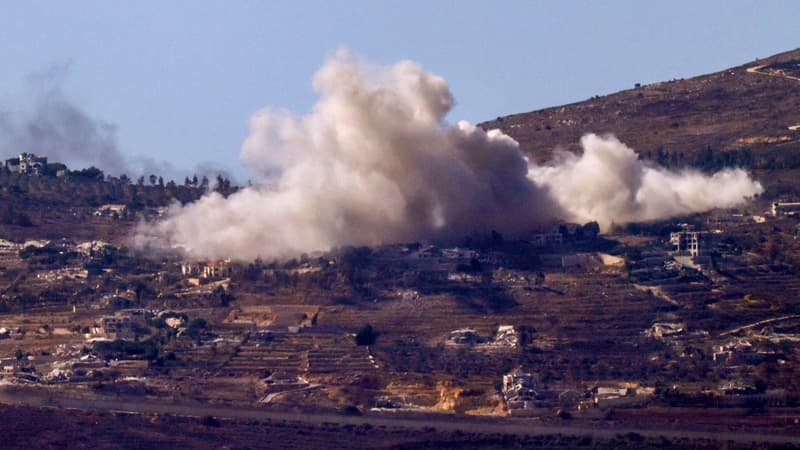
528 134 764 231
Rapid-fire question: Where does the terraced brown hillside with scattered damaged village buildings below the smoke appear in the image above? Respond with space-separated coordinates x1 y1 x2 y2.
0 153 800 426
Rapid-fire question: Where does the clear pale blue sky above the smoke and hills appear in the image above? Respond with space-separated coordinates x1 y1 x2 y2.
0 0 800 179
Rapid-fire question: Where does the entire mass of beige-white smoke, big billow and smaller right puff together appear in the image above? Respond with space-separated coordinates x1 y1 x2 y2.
135 50 760 260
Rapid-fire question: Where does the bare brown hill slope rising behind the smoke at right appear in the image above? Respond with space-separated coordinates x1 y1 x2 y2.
480 49 800 192
